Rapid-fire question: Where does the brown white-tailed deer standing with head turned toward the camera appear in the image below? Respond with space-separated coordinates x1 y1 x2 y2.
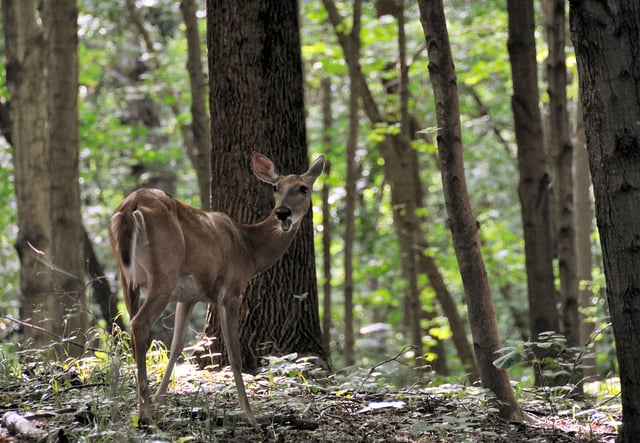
109 152 324 426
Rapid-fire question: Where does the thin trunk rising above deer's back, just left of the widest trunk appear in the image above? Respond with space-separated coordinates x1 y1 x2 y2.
180 0 211 209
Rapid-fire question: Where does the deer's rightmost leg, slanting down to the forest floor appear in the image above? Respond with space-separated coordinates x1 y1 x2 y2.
218 291 258 427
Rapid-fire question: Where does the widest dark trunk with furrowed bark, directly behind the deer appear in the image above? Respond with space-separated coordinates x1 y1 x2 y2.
200 0 328 371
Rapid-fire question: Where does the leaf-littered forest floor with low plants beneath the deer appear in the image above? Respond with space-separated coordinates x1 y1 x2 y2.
0 348 620 443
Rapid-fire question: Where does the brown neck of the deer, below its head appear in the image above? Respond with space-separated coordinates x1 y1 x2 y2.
242 212 300 274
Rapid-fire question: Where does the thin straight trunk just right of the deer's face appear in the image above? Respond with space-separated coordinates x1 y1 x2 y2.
322 77 333 356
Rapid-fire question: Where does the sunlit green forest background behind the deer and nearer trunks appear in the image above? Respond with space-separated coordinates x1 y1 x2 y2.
0 0 632 442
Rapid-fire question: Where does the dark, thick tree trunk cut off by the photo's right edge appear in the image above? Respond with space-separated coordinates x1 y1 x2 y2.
570 0 640 442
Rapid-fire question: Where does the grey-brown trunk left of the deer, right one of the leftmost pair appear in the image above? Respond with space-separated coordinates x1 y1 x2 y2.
43 0 89 355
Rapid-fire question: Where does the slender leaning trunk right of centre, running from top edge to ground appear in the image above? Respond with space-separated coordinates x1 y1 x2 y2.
418 0 523 419
